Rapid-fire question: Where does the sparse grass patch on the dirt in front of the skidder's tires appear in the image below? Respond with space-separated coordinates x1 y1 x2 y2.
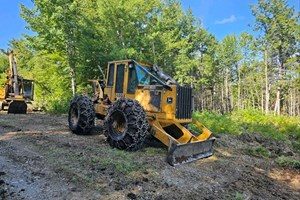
36 142 150 178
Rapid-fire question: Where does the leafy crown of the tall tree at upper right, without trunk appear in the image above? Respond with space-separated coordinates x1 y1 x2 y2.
251 0 300 57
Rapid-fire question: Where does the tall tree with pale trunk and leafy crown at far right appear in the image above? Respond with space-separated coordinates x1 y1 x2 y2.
251 0 300 114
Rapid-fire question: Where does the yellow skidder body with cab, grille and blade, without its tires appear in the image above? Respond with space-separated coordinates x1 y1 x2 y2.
92 60 215 165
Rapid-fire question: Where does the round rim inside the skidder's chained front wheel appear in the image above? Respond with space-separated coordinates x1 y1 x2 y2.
109 111 127 140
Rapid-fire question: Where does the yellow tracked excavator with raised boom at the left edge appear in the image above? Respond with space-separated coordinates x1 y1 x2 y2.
0 51 34 114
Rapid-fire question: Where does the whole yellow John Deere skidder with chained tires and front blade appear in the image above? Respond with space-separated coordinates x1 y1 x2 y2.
68 60 214 165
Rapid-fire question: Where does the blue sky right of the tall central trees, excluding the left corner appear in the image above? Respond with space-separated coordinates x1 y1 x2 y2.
181 0 300 40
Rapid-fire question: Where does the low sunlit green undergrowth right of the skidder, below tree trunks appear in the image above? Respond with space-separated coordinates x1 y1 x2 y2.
193 109 300 141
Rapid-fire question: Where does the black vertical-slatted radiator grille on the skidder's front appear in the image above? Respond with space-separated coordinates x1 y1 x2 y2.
176 86 193 119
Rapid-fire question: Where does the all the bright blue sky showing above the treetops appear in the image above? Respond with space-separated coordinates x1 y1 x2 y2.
0 0 300 49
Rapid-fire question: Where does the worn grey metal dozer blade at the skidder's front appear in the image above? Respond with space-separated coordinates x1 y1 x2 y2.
167 138 215 166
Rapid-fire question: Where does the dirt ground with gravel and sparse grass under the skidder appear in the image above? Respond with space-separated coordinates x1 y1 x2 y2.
0 113 300 200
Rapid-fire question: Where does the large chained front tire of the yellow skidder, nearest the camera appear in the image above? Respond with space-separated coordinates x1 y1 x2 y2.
103 98 149 151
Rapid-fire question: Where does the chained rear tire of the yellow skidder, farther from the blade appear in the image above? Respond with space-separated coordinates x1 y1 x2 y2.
68 95 95 134
